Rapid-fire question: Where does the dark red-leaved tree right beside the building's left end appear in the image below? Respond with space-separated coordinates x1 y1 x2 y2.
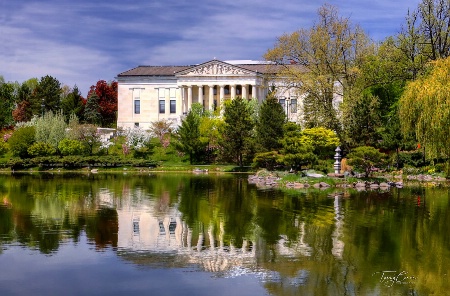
88 80 118 127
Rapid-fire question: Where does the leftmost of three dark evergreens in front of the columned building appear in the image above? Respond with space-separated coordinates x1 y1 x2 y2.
177 110 206 164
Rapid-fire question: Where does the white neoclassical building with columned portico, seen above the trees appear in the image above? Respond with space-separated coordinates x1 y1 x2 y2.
117 60 300 129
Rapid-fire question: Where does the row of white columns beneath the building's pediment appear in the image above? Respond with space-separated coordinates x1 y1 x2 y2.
181 84 265 112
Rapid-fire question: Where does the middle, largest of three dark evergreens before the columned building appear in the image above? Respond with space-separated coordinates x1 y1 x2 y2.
221 97 255 166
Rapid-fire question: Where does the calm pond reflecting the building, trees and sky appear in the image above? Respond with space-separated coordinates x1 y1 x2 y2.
0 173 450 295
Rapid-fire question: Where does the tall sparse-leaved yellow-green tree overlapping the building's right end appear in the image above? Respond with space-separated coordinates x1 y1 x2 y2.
265 4 373 132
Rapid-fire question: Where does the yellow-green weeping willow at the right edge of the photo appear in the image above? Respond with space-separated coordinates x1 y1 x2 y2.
399 58 450 158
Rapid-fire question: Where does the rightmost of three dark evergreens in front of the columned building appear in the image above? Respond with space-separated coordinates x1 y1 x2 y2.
256 93 286 152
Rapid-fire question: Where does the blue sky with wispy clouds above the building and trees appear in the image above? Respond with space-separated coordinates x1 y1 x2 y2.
0 0 420 95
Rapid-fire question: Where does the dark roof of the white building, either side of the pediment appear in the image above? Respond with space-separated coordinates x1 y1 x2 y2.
118 60 292 77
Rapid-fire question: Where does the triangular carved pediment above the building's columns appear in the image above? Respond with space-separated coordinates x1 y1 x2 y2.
175 60 257 76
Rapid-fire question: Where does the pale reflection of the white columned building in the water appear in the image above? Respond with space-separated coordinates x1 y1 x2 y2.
117 207 256 272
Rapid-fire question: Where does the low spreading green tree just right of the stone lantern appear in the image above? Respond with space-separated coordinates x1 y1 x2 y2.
347 146 386 178
